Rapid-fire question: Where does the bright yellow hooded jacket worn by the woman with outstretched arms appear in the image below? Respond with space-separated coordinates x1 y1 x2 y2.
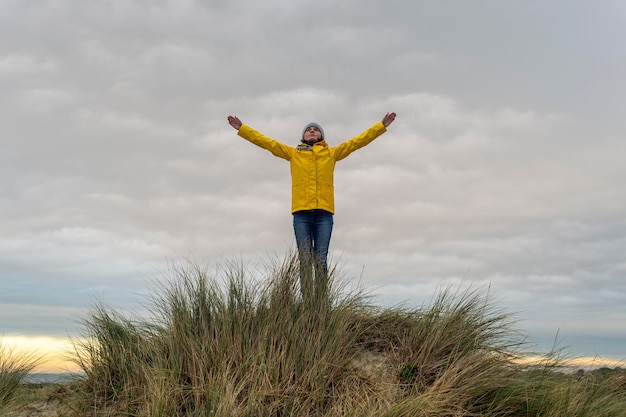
238 122 387 213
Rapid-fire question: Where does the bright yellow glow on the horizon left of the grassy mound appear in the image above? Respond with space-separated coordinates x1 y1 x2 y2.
0 336 80 373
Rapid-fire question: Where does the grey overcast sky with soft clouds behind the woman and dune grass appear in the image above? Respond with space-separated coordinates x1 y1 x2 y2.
0 0 626 359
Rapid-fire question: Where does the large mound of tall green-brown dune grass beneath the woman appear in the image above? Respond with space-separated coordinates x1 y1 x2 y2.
70 258 626 417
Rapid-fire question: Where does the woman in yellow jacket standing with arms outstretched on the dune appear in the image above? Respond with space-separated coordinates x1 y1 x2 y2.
228 112 396 294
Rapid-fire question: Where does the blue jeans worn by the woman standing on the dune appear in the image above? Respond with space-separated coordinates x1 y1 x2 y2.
293 209 333 294
